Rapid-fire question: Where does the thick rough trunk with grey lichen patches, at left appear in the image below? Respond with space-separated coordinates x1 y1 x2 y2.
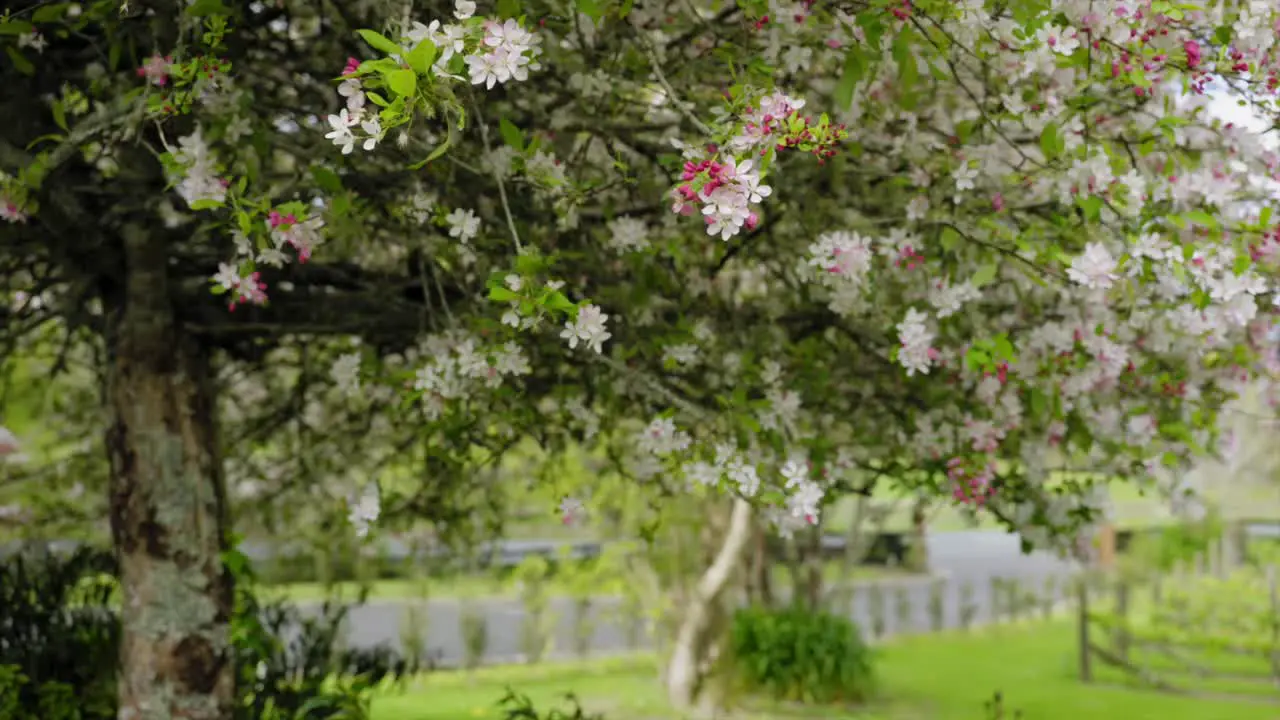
105 227 234 720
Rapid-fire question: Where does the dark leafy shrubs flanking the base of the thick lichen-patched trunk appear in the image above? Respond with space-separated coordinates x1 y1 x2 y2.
0 547 416 720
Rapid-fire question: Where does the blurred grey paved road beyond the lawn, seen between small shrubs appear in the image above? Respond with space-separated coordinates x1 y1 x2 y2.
307 530 1071 665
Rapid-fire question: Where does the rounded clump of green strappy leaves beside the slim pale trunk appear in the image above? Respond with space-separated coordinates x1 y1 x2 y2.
730 607 874 703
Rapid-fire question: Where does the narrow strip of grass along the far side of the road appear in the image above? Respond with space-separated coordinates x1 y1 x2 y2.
261 564 913 602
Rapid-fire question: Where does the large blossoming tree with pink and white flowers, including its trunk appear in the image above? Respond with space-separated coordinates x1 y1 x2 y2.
0 0 1280 717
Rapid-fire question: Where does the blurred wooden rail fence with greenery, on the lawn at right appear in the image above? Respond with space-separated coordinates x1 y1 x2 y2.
1076 543 1280 702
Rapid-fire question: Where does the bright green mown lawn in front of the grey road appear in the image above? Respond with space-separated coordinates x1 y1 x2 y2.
372 620 1280 720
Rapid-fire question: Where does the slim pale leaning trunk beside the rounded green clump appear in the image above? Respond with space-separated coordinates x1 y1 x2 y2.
667 498 751 711
